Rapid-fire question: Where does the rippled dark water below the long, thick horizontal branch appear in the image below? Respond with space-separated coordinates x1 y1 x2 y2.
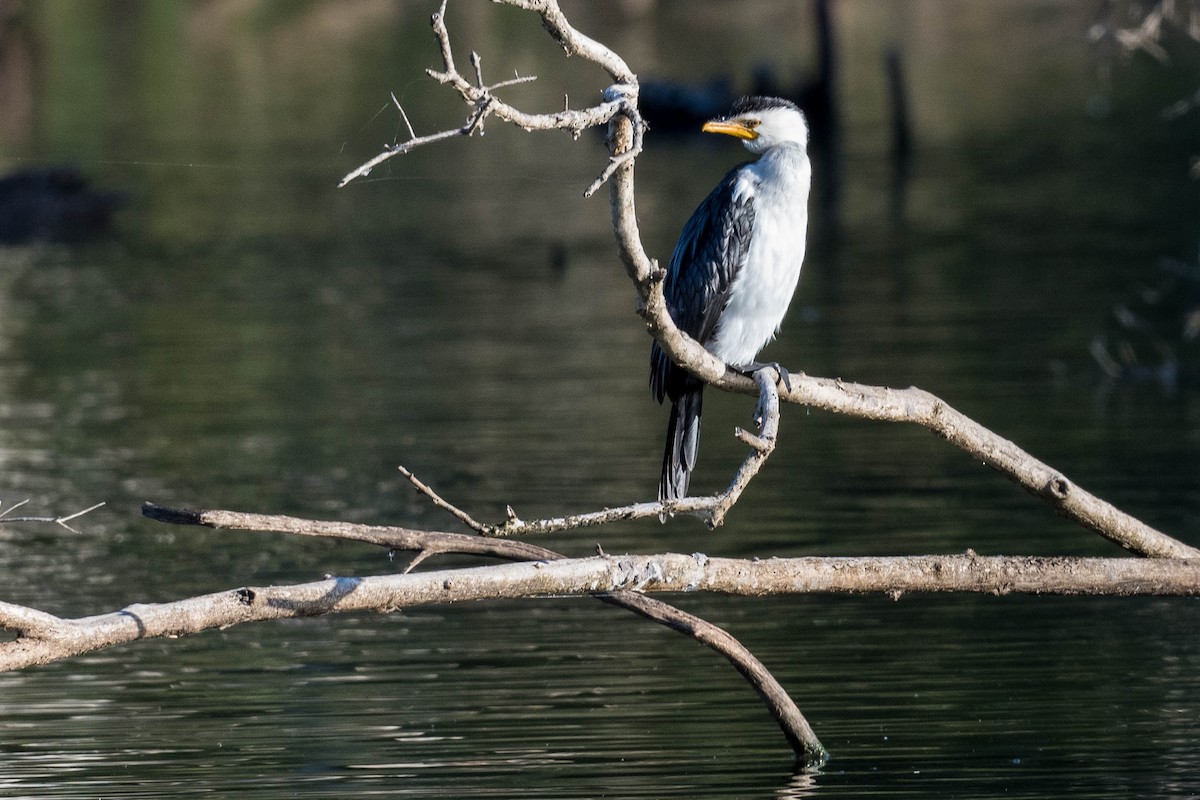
7 599 1200 798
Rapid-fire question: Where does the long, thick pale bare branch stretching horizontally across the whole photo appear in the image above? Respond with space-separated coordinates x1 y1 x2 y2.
0 553 1200 669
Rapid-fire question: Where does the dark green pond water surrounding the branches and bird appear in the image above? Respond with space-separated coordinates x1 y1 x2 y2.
0 0 1200 798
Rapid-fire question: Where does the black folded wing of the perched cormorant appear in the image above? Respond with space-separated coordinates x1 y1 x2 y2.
650 164 754 403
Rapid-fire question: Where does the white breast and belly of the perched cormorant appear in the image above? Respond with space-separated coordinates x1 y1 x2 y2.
708 146 812 366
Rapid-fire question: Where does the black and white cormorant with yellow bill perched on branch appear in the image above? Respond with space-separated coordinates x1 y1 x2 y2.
650 97 812 500
